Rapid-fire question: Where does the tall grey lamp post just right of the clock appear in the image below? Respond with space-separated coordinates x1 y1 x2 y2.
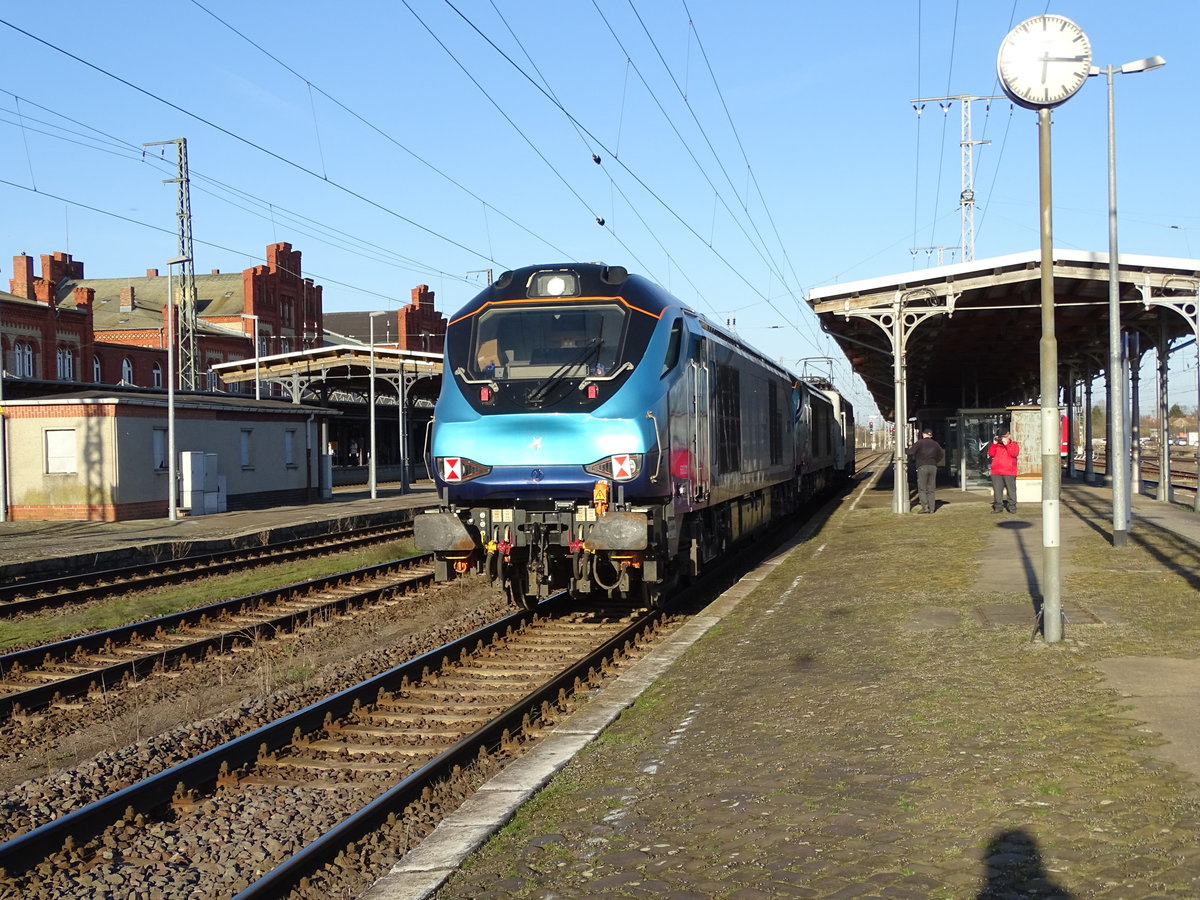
1088 56 1166 547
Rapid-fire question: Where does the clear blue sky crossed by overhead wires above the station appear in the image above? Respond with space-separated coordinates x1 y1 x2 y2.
0 0 1200 409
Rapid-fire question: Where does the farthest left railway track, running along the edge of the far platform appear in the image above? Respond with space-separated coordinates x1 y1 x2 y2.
0 523 413 617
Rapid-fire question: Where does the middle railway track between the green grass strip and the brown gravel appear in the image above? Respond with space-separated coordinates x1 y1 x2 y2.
0 554 433 720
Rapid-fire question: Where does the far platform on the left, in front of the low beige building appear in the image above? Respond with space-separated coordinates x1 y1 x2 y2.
0 481 438 581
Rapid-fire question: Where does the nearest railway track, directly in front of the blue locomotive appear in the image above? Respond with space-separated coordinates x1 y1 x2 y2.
0 604 662 900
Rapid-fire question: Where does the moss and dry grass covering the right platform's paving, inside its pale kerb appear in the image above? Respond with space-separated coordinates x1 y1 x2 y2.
439 505 1200 900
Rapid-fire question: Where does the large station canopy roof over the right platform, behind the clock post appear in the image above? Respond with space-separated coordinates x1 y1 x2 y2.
809 250 1200 419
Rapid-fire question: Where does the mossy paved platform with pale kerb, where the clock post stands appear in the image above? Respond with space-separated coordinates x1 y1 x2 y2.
365 463 1200 900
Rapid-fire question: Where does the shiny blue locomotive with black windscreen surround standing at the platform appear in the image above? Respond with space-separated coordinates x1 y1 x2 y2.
414 264 854 605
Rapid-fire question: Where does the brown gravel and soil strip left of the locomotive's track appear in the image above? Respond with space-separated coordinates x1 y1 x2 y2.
0 578 508 840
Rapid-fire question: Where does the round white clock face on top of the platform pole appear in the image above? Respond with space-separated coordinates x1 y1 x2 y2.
996 16 1092 109
